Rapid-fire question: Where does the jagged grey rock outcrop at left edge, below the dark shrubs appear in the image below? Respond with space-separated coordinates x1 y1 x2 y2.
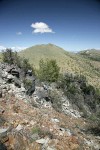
0 64 35 97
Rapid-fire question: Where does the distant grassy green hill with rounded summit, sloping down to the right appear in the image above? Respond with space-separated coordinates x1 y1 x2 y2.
19 44 100 87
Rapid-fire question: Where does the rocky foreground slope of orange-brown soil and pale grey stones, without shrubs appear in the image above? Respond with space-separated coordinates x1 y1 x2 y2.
0 64 100 150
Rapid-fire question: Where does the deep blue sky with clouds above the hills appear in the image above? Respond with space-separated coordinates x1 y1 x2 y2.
0 0 100 51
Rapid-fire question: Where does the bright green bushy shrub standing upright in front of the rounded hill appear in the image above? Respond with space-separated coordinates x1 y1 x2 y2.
38 59 60 82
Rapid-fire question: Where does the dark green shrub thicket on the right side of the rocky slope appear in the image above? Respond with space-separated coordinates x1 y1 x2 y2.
58 73 100 113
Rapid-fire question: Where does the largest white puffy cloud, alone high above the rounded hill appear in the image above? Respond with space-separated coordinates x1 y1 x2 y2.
31 22 54 33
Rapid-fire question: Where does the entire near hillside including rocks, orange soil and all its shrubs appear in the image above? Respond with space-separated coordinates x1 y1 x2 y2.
0 45 100 150
